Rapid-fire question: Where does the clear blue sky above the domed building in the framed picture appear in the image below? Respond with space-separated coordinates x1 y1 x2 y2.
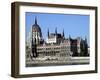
25 12 89 44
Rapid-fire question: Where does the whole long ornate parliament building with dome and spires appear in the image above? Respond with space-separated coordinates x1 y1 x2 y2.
26 18 89 59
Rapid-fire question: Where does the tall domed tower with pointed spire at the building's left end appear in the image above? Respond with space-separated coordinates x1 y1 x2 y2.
31 17 43 57
